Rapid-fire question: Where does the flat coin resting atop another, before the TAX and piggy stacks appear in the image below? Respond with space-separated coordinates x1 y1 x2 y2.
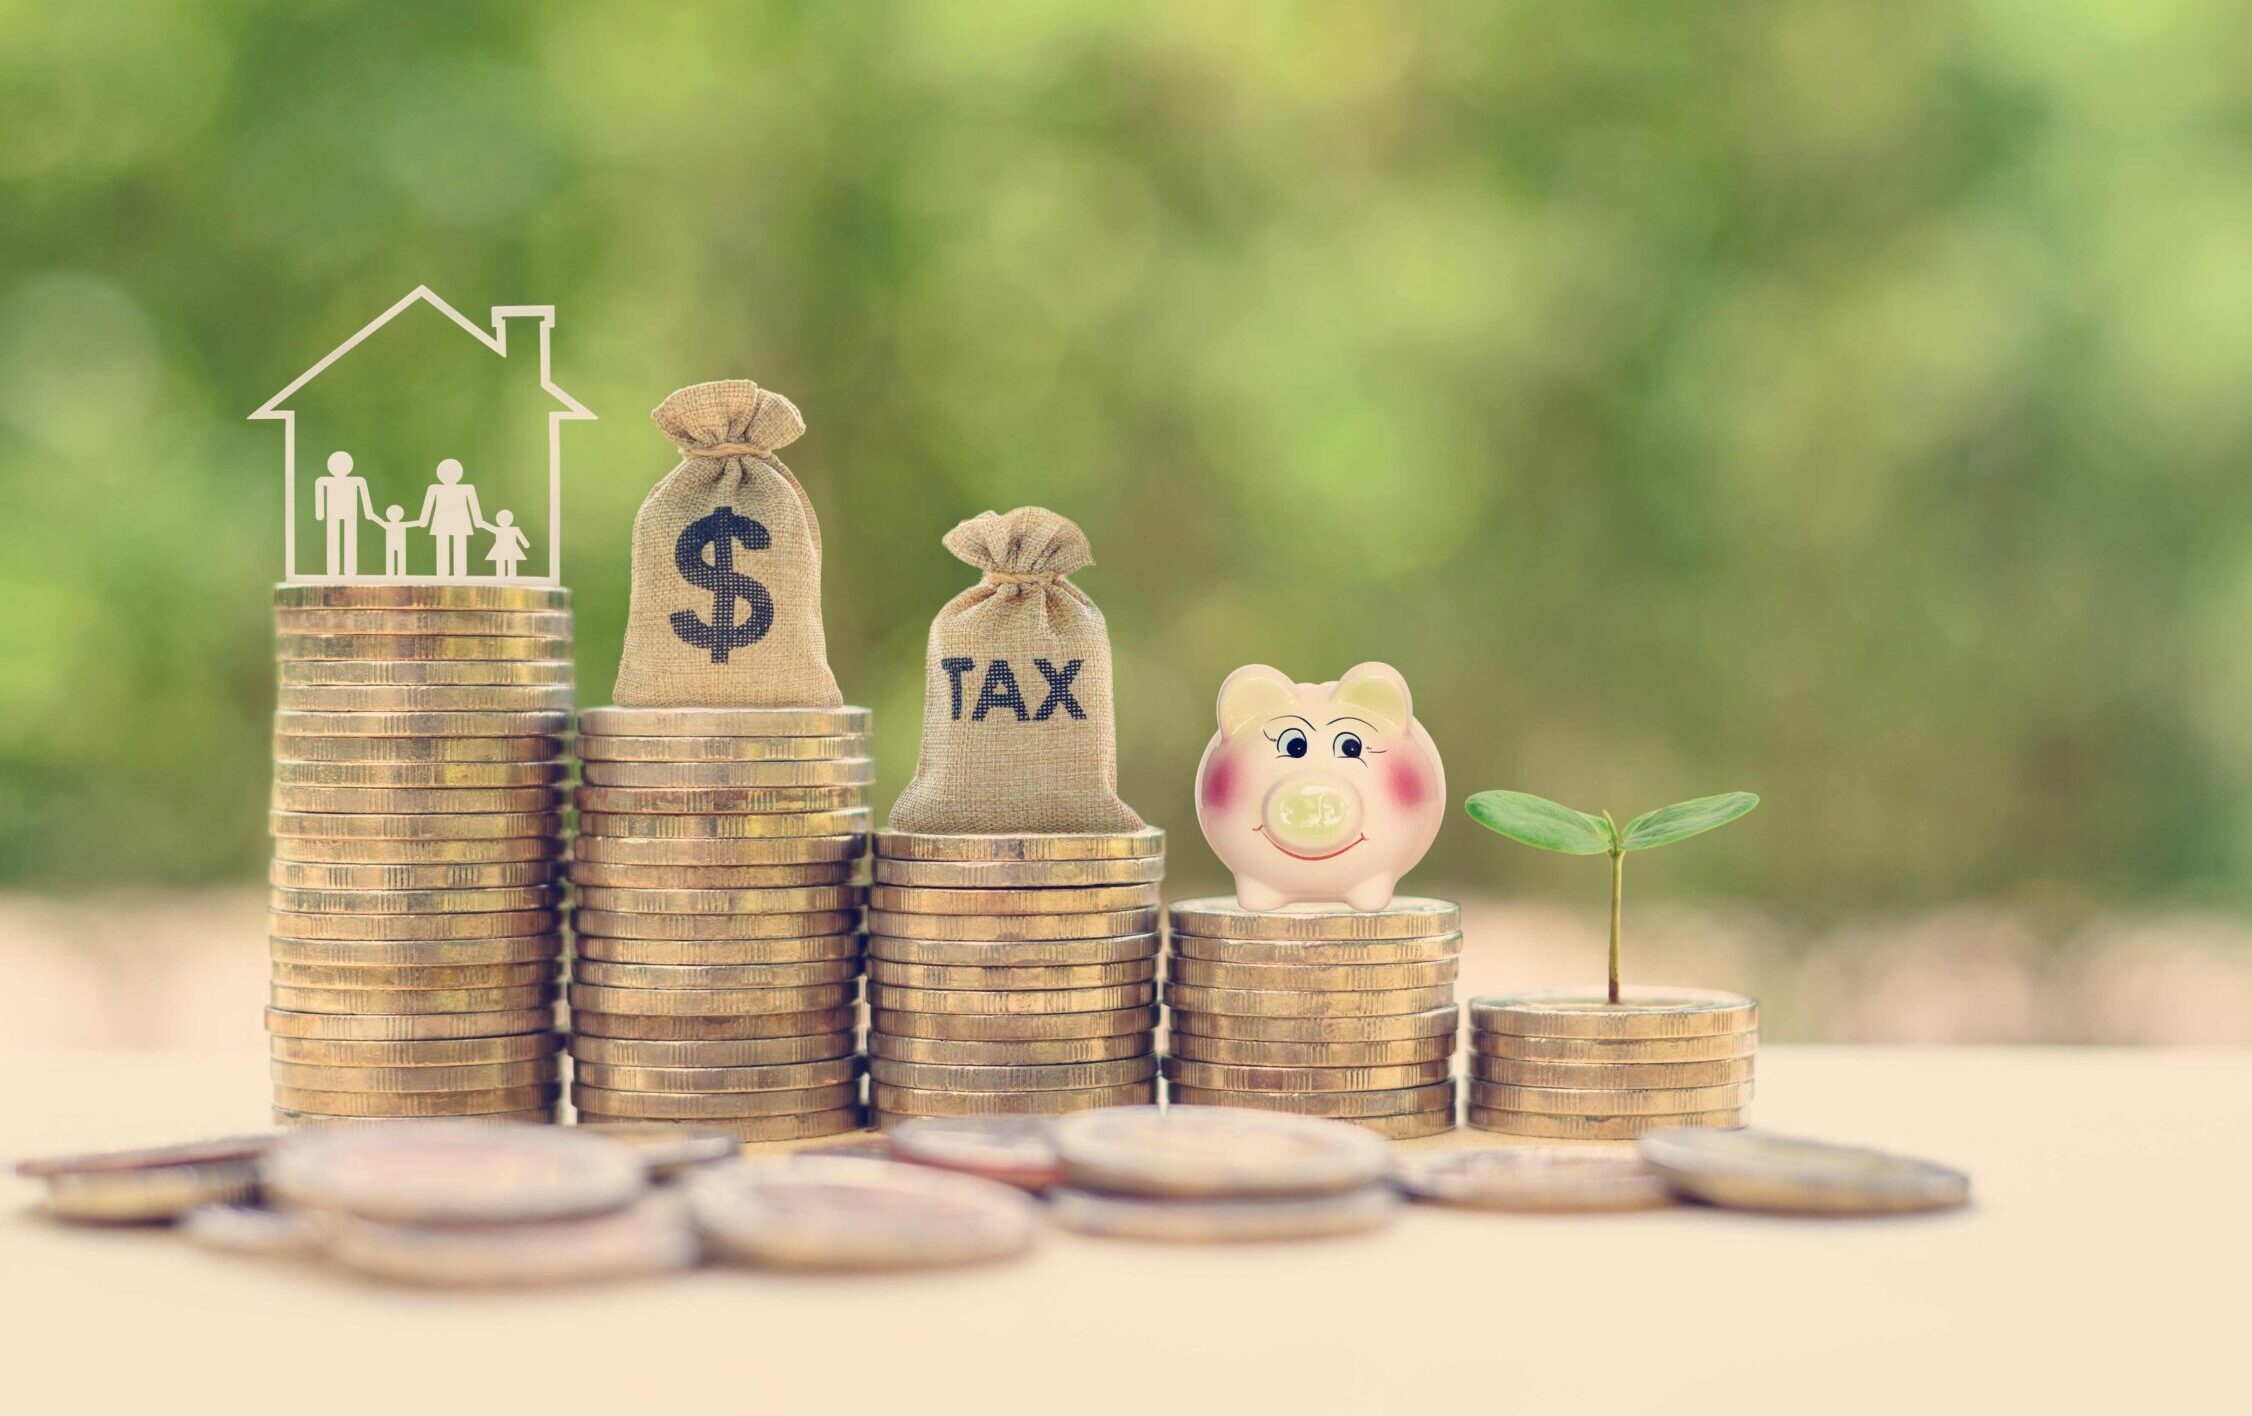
1056 1105 1392 1198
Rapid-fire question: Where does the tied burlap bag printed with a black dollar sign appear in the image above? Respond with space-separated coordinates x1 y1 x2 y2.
617 378 845 707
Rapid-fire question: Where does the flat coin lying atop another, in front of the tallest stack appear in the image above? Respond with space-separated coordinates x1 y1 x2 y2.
266 1121 649 1225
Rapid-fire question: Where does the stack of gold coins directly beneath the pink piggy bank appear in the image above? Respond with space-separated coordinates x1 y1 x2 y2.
1164 896 1462 1139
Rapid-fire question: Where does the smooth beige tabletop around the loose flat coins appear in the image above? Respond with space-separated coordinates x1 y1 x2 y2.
0 1047 2252 1416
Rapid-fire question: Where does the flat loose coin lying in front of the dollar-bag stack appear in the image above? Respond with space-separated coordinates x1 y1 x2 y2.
685 1155 1040 1270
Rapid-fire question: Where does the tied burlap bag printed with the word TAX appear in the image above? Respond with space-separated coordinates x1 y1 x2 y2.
892 507 1142 833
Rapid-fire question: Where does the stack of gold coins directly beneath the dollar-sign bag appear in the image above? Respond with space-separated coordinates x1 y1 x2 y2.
570 707 874 1141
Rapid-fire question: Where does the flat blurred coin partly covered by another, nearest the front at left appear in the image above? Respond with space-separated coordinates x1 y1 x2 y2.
327 1188 700 1288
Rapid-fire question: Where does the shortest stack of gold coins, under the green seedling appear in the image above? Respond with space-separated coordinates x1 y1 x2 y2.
1468 988 1759 1141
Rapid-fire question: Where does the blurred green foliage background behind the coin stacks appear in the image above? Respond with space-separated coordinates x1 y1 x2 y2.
0 0 2252 912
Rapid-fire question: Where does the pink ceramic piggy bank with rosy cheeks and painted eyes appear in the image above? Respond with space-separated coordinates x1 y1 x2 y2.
1196 664 1446 909
